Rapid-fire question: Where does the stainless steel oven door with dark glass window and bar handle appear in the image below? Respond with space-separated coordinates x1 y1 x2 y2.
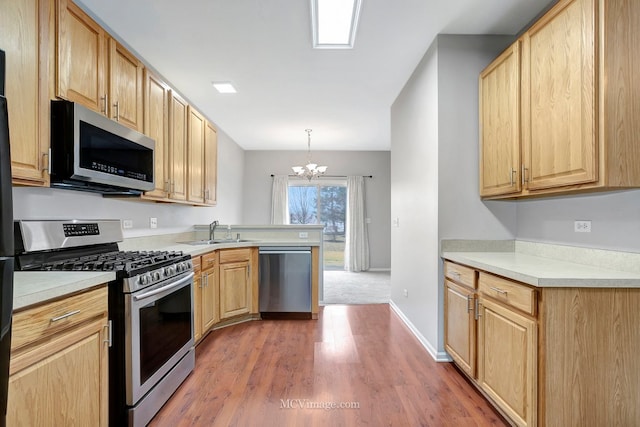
125 272 194 406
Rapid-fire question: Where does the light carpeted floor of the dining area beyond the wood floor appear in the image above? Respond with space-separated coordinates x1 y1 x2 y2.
321 270 391 304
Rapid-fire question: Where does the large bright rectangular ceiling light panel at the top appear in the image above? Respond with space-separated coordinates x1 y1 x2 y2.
311 0 361 49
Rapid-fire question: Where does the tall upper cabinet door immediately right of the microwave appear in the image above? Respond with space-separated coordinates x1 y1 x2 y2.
144 69 170 199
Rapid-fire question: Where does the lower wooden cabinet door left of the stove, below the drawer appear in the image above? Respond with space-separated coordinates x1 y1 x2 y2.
7 318 109 427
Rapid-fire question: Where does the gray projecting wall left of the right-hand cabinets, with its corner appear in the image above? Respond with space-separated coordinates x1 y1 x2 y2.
391 35 516 358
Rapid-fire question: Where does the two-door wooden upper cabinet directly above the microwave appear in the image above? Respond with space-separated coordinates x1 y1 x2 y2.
55 0 143 131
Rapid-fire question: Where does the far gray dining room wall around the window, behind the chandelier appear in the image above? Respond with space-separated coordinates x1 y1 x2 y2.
243 152 391 269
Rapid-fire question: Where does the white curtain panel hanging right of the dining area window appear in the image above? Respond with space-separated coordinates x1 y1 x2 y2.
344 176 369 271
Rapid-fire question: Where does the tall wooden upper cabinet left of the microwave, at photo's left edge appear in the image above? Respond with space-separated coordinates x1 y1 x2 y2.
0 0 49 186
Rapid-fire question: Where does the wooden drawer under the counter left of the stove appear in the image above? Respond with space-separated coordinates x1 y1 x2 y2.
11 286 107 351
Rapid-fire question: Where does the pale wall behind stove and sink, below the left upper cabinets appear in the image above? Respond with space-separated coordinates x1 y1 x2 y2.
13 131 244 237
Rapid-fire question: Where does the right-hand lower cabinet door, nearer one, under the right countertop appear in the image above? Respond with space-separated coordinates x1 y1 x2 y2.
478 298 537 426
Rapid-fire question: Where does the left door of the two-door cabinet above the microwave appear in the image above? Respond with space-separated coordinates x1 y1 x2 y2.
56 0 108 114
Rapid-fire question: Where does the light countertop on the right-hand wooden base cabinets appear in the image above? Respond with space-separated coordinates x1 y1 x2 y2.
442 252 640 288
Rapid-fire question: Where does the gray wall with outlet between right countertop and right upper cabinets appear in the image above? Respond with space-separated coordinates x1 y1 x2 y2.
516 190 640 252
